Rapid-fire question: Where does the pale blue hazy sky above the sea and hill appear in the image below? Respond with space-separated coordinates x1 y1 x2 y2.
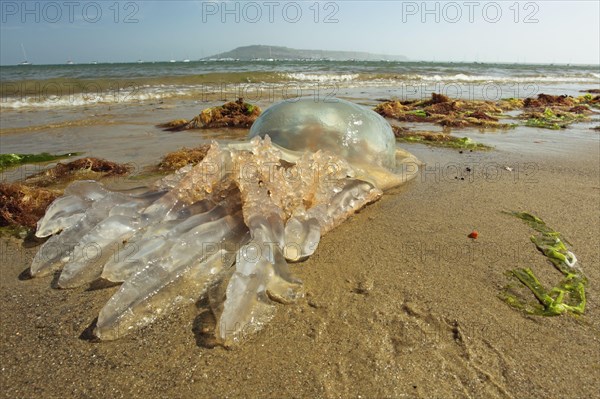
0 0 600 65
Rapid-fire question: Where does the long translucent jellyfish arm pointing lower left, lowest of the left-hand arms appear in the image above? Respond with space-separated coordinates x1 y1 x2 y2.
94 213 248 340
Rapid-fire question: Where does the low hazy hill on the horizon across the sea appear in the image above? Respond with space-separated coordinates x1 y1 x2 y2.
203 45 408 61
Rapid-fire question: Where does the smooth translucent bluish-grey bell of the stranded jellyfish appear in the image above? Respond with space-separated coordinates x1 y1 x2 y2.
249 97 396 169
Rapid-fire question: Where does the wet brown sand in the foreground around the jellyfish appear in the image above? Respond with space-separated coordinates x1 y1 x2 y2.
0 103 600 399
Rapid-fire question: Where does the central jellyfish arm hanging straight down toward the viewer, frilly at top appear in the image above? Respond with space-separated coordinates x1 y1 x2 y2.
217 154 302 345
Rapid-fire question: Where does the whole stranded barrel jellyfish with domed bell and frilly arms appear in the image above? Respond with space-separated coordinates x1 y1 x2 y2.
31 99 418 346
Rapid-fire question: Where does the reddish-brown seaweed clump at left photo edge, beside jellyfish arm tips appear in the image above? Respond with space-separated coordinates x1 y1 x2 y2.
0 183 61 229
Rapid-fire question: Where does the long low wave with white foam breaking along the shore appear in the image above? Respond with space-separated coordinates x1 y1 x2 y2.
0 73 600 110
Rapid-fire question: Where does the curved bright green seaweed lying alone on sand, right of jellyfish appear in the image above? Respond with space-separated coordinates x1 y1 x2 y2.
501 212 587 316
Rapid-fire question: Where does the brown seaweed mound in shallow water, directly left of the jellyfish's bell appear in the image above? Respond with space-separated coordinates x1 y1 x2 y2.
158 98 262 131
